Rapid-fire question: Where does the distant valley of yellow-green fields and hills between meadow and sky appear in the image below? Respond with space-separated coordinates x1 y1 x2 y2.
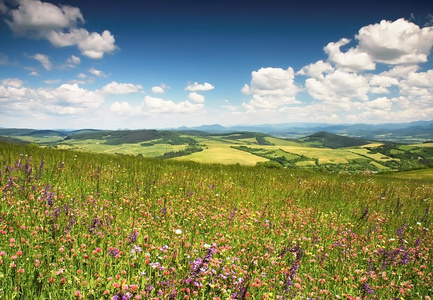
0 122 433 173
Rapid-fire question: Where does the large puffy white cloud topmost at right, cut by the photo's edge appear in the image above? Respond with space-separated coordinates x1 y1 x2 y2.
356 19 433 64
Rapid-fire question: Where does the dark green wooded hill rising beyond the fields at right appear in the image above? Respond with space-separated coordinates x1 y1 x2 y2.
300 131 371 149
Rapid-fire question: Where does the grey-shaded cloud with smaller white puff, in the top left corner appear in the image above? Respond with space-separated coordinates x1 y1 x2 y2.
6 0 117 59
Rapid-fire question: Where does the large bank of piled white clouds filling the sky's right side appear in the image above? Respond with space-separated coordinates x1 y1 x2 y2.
240 19 433 123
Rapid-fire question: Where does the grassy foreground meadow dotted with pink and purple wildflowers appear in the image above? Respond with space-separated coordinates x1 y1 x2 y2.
0 143 433 299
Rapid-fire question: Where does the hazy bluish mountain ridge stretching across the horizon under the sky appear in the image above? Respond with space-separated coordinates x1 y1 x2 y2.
0 120 433 143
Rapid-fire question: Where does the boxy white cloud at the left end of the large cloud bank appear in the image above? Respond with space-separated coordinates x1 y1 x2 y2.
242 68 300 110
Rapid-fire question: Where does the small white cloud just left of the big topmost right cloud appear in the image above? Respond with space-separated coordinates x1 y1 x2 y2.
324 38 376 71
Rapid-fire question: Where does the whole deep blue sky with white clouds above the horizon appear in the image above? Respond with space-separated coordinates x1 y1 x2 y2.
0 0 433 129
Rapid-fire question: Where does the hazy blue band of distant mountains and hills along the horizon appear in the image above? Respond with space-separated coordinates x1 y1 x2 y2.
0 120 433 144
